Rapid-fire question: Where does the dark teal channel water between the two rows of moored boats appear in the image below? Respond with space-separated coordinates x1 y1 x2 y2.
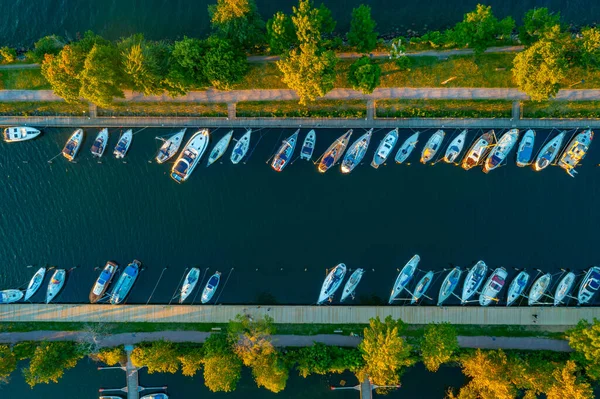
0 129 600 304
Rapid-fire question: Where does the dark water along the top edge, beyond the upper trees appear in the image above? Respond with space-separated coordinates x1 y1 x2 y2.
0 0 600 46
